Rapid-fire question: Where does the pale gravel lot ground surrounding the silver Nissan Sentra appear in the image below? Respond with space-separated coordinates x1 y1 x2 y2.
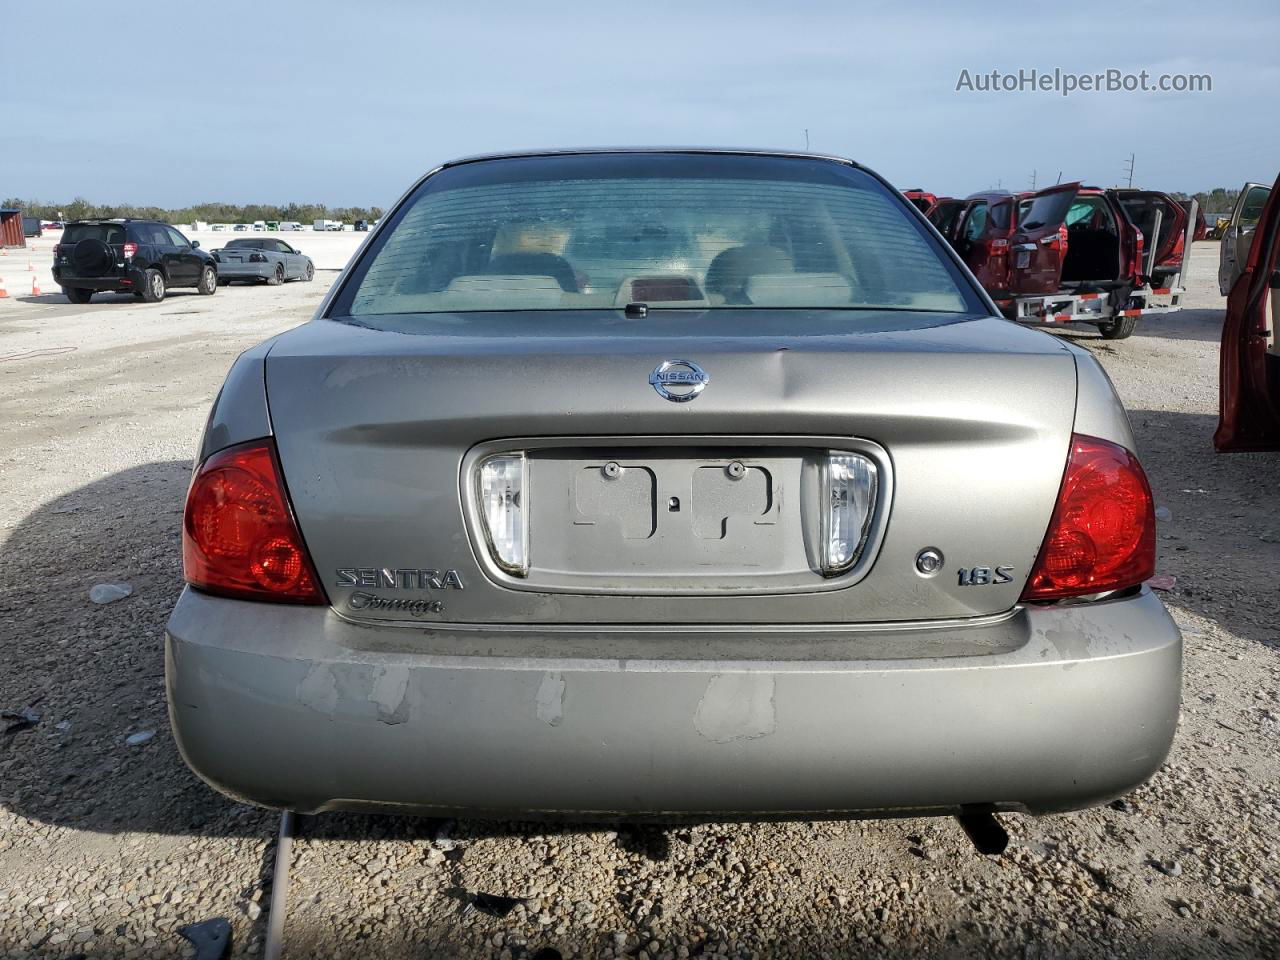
0 234 1280 960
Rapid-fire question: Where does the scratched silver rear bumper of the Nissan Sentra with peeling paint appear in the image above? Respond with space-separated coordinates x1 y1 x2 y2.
166 590 1181 818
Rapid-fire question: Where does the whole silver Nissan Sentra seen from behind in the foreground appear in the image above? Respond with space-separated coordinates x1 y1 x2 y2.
166 150 1181 819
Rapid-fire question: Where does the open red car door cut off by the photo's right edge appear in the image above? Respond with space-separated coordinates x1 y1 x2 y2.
1213 171 1280 451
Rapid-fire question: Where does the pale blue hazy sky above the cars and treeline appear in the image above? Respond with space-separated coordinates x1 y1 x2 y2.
0 0 1280 206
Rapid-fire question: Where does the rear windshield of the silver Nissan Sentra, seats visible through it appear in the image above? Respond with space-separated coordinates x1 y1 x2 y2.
334 154 980 316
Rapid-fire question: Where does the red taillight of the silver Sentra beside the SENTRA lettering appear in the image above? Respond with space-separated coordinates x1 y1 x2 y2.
182 440 325 603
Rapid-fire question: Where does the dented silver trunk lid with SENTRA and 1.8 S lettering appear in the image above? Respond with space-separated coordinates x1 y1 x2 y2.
266 316 1075 625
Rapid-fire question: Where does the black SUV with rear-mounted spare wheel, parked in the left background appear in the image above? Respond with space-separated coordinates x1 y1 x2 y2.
54 220 218 303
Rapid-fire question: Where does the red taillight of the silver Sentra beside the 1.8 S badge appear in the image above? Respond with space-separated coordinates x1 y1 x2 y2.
1023 434 1156 600
